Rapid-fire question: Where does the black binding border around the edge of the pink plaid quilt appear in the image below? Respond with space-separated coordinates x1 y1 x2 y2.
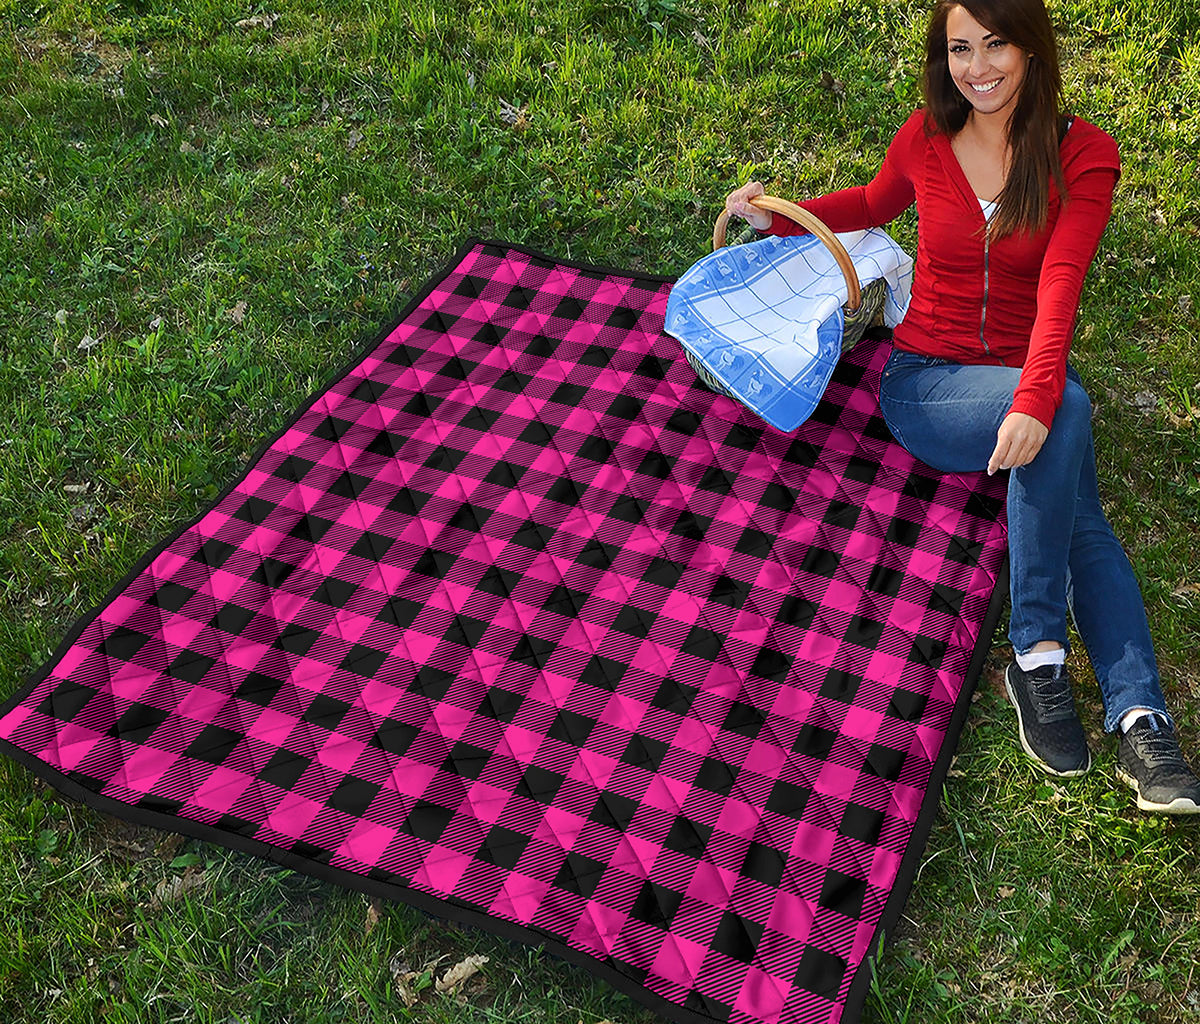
0 235 1008 1024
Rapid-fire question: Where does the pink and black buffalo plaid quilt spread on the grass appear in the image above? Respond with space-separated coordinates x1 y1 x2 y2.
0 242 1006 1024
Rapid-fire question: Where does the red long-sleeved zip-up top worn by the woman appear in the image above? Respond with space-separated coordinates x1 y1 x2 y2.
769 109 1121 427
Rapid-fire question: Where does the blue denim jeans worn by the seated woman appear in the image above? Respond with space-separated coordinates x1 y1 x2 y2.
880 349 1169 732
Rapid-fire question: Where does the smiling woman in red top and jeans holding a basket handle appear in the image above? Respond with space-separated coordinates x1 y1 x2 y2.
726 0 1200 814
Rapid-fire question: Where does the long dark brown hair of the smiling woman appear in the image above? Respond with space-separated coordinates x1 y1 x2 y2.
923 0 1067 238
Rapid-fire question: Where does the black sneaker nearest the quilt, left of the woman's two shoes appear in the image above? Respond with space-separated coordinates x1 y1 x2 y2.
1004 661 1092 778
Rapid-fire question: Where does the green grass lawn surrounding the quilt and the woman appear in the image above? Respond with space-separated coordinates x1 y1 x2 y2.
0 0 1200 1024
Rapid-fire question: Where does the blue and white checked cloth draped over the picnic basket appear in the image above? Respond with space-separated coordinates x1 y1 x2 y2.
666 228 913 431
